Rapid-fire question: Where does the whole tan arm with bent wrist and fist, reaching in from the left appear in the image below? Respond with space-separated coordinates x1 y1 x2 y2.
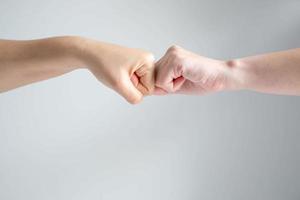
0 36 154 104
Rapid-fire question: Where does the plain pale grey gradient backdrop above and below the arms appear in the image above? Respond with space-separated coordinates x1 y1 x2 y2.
0 0 300 200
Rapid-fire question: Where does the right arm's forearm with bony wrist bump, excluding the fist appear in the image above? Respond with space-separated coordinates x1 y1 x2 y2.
226 49 300 95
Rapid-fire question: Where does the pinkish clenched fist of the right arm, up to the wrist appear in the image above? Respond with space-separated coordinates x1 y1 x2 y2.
154 46 234 95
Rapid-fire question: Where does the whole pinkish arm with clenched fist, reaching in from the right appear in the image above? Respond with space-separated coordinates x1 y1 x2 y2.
154 46 300 95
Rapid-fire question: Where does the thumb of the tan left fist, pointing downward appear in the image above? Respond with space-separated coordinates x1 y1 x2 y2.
118 73 143 104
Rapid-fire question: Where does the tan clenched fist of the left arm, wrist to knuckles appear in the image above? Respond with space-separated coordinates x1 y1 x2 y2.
81 39 154 104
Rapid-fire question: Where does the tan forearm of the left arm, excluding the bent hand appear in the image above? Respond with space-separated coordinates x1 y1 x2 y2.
0 37 83 92
